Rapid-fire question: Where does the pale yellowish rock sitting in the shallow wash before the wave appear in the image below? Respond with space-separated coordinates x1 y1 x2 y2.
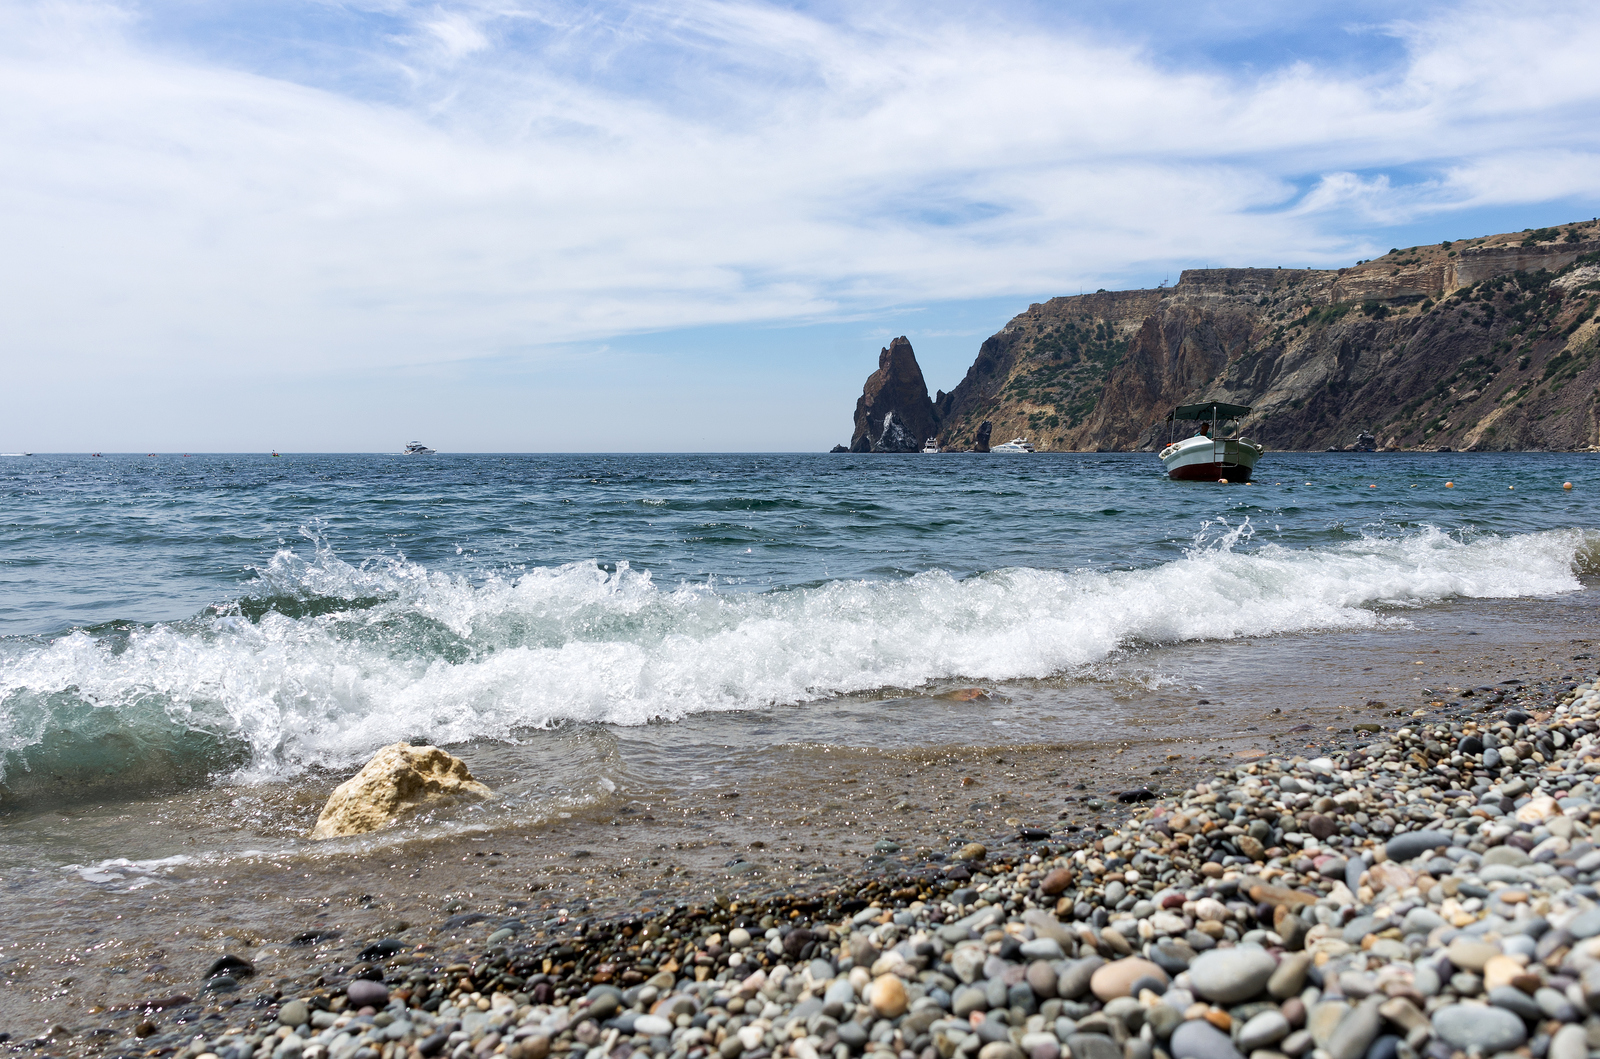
310 742 493 838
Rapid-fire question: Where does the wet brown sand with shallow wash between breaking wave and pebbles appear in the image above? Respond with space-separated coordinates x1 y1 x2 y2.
0 589 1600 1048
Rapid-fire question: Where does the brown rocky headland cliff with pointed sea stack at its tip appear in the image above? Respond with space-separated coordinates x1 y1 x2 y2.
851 221 1600 451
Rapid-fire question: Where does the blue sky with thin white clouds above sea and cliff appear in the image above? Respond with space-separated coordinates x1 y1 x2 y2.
0 0 1600 451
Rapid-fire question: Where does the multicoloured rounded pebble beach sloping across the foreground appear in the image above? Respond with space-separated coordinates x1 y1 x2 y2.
18 659 1600 1059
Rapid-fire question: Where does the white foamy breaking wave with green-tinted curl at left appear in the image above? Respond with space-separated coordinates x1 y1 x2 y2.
0 522 1600 801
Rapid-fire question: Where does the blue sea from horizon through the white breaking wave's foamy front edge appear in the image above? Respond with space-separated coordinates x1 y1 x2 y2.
0 453 1600 808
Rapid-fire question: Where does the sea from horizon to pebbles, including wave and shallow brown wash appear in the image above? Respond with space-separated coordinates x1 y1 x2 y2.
0 453 1600 1025
